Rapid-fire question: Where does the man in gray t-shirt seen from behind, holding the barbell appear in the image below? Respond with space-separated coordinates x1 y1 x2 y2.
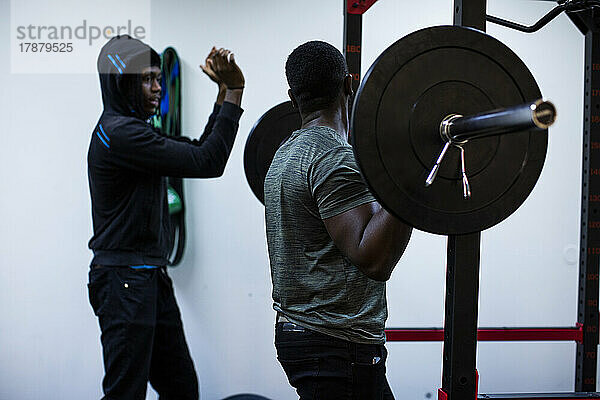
265 41 411 400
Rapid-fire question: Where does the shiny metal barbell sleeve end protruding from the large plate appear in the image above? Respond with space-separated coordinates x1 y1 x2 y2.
441 99 556 143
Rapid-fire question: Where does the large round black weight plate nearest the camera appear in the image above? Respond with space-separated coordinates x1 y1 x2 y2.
351 26 548 234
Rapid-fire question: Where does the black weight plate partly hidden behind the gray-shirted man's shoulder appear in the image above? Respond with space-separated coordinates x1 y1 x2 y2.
244 101 302 204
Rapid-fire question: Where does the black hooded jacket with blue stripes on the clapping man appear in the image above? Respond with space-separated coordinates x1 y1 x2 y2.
88 36 242 265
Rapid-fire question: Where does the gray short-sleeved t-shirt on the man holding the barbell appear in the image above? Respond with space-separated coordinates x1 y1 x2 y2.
265 126 387 344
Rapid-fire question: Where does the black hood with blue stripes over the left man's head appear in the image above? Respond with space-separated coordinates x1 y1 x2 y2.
97 35 160 119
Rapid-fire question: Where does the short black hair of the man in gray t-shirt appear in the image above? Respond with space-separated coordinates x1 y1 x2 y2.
285 40 348 113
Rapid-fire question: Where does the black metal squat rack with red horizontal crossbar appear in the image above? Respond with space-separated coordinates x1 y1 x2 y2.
344 0 600 400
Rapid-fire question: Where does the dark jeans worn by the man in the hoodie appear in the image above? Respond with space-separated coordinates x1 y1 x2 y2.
88 267 199 400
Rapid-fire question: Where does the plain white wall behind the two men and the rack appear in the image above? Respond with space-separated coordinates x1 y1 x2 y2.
0 0 583 400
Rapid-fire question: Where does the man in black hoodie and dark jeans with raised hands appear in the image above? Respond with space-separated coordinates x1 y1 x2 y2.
88 35 244 400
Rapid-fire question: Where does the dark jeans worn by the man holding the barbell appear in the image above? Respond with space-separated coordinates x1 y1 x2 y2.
275 322 394 400
